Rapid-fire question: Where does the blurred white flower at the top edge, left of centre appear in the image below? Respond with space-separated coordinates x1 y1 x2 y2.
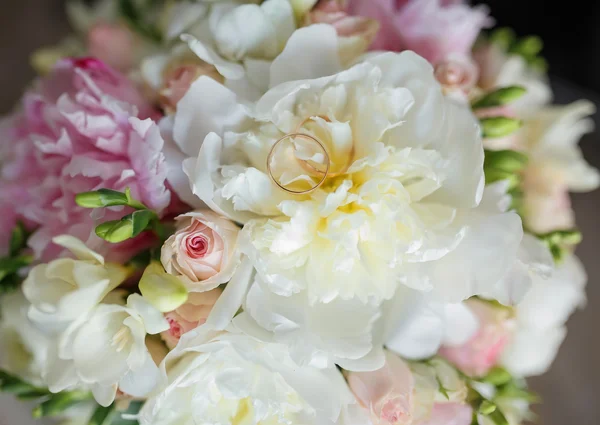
141 0 296 103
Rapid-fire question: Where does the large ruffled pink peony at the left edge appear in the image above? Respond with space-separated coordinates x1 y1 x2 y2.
0 58 171 261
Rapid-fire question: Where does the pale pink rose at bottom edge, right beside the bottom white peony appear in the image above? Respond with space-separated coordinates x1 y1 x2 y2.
347 352 415 425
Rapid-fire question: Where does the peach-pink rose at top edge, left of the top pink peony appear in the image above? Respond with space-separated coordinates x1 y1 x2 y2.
304 0 379 62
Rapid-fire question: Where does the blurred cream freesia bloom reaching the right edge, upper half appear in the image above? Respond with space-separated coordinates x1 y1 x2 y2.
520 100 600 233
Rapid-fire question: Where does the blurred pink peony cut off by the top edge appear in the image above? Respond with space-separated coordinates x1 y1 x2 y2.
348 0 492 64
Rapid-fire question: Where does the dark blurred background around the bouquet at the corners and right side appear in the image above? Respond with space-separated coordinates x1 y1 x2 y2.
0 0 600 425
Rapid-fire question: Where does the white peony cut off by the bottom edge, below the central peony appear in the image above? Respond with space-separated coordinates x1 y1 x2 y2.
139 326 361 425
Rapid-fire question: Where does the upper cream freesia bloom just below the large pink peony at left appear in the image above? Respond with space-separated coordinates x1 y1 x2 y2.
23 235 128 330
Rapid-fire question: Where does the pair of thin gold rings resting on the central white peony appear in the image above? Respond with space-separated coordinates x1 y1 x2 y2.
267 116 354 195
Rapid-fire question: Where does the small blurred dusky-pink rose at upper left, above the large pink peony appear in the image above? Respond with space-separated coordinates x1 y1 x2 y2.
87 23 138 72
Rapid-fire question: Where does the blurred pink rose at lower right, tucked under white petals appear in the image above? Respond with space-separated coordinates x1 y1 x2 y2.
438 300 513 377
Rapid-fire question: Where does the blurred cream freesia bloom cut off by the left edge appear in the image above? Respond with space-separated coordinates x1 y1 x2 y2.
0 290 49 385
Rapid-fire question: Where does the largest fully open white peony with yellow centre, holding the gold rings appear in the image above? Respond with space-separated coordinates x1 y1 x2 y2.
174 30 522 369
